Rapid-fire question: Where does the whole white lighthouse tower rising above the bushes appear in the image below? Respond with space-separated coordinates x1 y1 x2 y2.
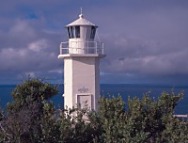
58 13 105 110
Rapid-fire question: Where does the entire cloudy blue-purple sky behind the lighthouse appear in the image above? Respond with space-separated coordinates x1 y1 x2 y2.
0 0 188 85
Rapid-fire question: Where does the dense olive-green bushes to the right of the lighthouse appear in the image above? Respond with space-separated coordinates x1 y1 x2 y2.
96 93 188 143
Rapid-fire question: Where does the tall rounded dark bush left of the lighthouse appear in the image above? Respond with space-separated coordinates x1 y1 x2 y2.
1 79 58 143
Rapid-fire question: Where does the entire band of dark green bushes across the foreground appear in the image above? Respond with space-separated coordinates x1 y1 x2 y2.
0 79 188 143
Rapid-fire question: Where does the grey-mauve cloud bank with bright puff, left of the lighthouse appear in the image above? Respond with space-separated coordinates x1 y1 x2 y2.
0 19 60 84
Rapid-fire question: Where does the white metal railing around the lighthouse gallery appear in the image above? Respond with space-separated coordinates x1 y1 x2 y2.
60 41 104 55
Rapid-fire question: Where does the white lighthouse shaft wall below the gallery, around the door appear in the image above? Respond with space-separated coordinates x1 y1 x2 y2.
64 57 100 109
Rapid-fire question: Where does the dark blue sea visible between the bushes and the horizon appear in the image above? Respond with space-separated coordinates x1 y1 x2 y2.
0 84 188 114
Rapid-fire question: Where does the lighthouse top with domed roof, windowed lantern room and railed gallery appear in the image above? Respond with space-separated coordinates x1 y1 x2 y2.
59 13 104 58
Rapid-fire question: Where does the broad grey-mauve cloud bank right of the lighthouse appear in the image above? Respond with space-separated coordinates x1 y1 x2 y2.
99 3 188 81
